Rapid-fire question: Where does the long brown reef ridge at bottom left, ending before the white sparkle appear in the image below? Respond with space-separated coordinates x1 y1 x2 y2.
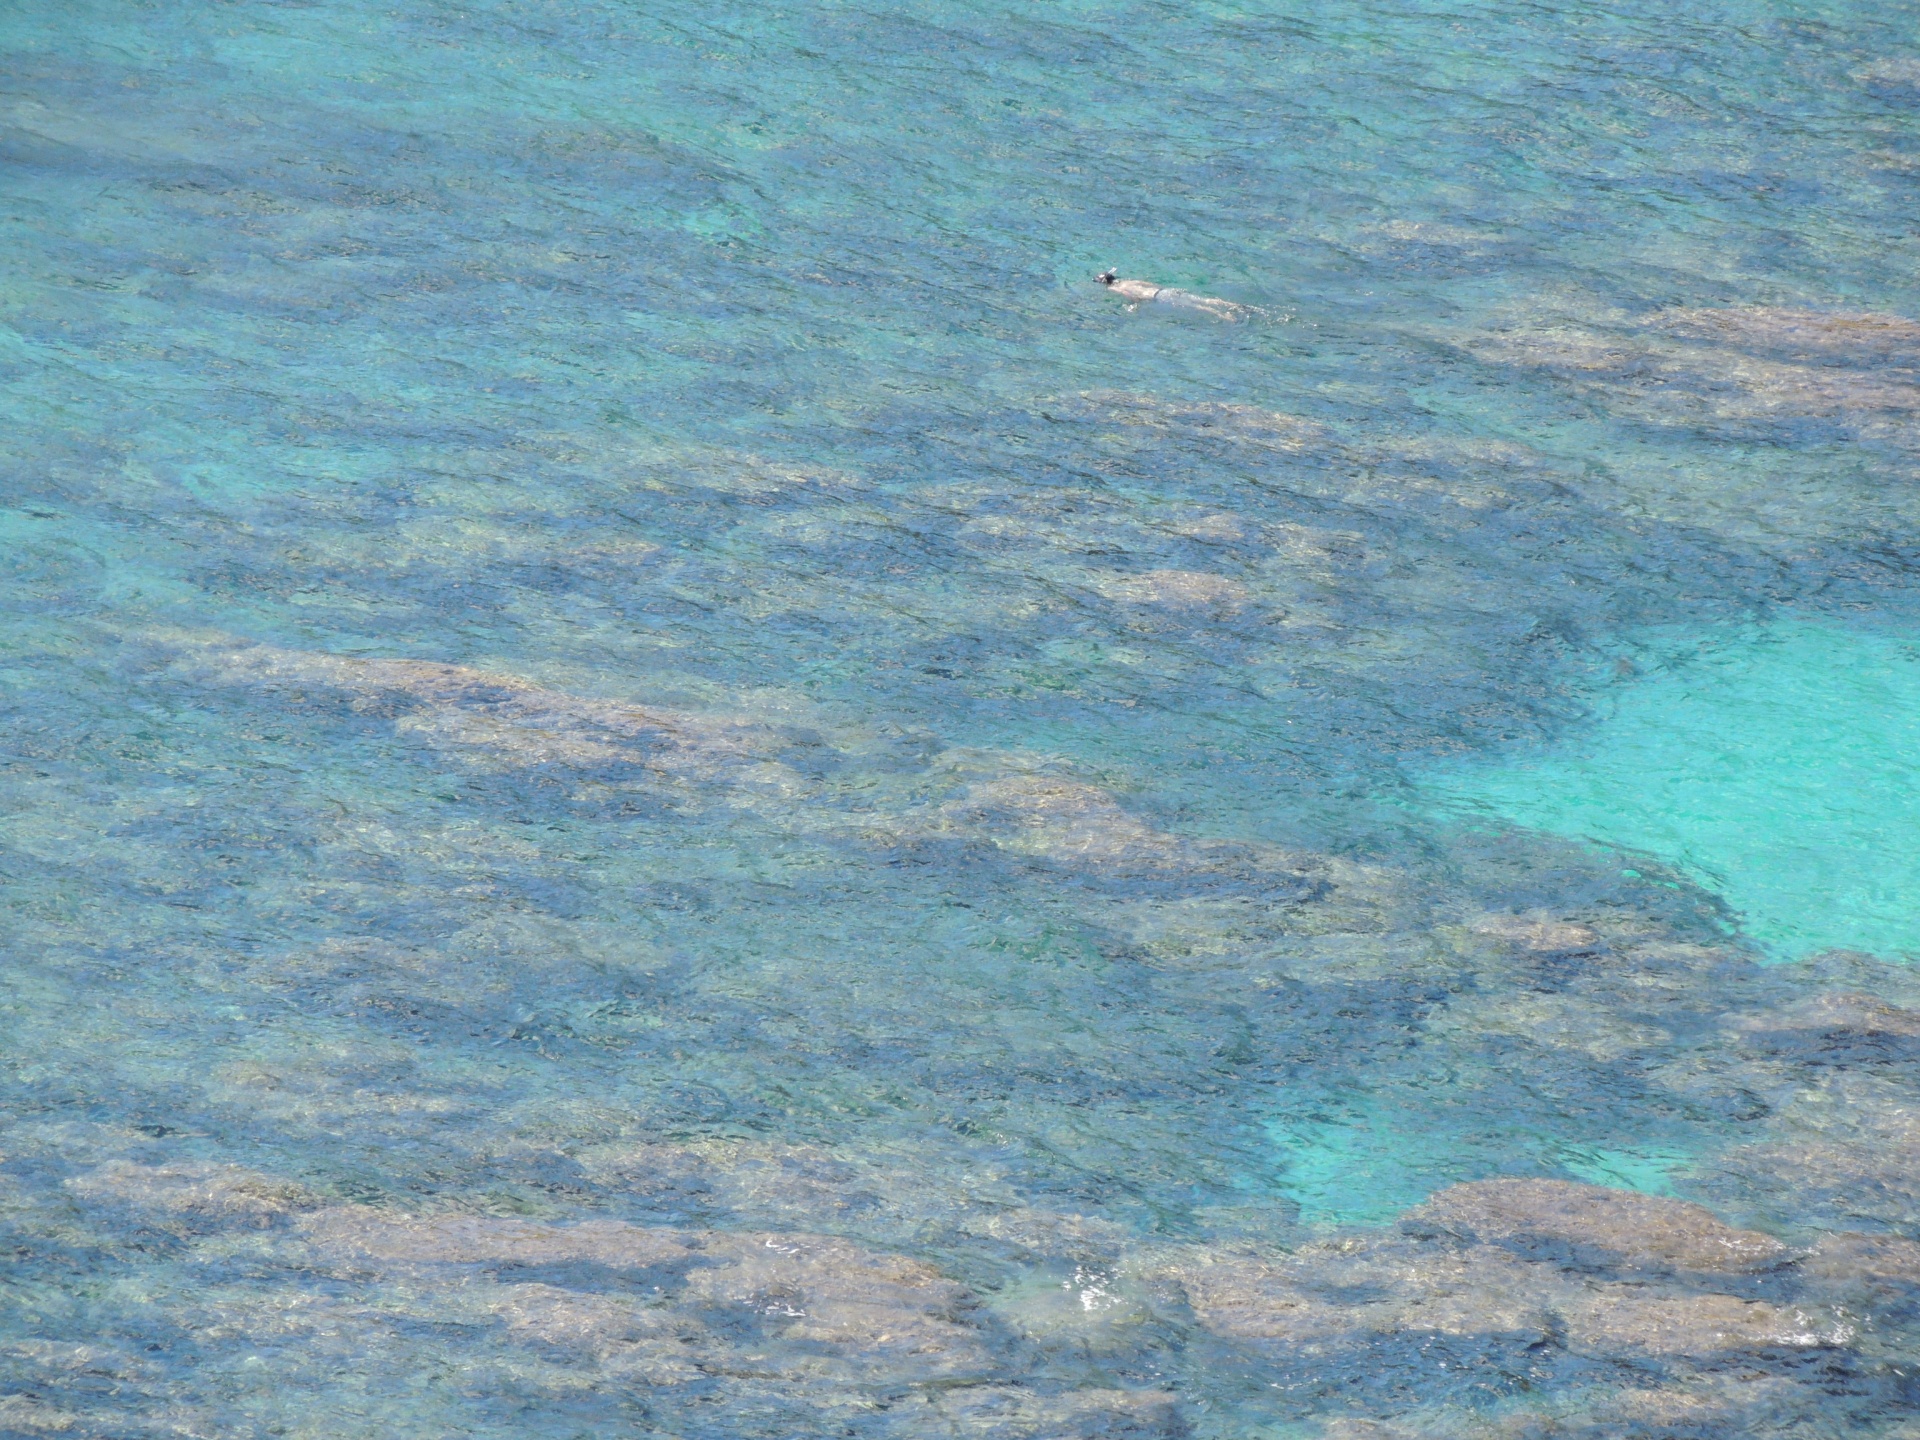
77 1164 1036 1398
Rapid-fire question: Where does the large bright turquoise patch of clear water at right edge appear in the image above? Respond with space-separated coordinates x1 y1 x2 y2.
1423 620 1920 960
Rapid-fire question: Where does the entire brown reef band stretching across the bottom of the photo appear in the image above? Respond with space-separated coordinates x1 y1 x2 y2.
60 1164 1920 1440
